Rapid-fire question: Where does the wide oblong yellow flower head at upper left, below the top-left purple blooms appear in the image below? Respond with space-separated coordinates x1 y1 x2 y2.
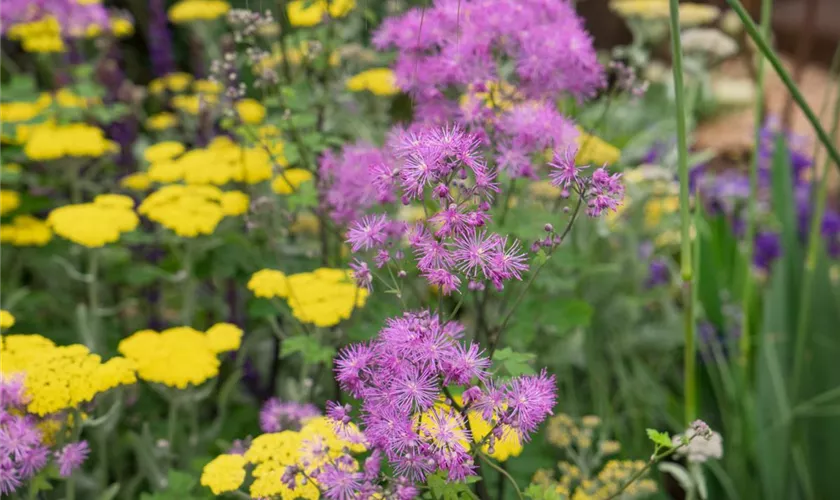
23 123 119 161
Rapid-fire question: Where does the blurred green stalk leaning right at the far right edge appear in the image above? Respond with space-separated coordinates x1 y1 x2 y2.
791 67 840 403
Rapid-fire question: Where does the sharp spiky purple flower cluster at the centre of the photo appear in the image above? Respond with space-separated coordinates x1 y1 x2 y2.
347 127 528 294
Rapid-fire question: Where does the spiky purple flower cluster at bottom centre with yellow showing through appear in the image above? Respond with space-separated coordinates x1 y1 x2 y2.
327 311 556 482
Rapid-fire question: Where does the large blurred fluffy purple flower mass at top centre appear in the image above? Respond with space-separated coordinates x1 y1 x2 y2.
374 0 605 121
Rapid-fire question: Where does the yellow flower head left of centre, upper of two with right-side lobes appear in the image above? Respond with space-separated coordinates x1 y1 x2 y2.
137 184 249 238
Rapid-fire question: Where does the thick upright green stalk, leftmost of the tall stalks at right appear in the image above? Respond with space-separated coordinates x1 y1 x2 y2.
669 0 697 424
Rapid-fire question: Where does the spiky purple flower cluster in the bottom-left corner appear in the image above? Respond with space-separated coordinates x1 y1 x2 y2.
0 375 87 495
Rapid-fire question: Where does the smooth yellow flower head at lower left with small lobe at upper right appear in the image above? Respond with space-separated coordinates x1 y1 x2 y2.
118 323 242 389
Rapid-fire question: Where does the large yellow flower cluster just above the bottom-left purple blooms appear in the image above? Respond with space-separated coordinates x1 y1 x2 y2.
0 334 137 416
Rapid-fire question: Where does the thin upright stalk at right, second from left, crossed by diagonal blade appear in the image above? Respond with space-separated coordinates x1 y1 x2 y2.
738 0 773 382
